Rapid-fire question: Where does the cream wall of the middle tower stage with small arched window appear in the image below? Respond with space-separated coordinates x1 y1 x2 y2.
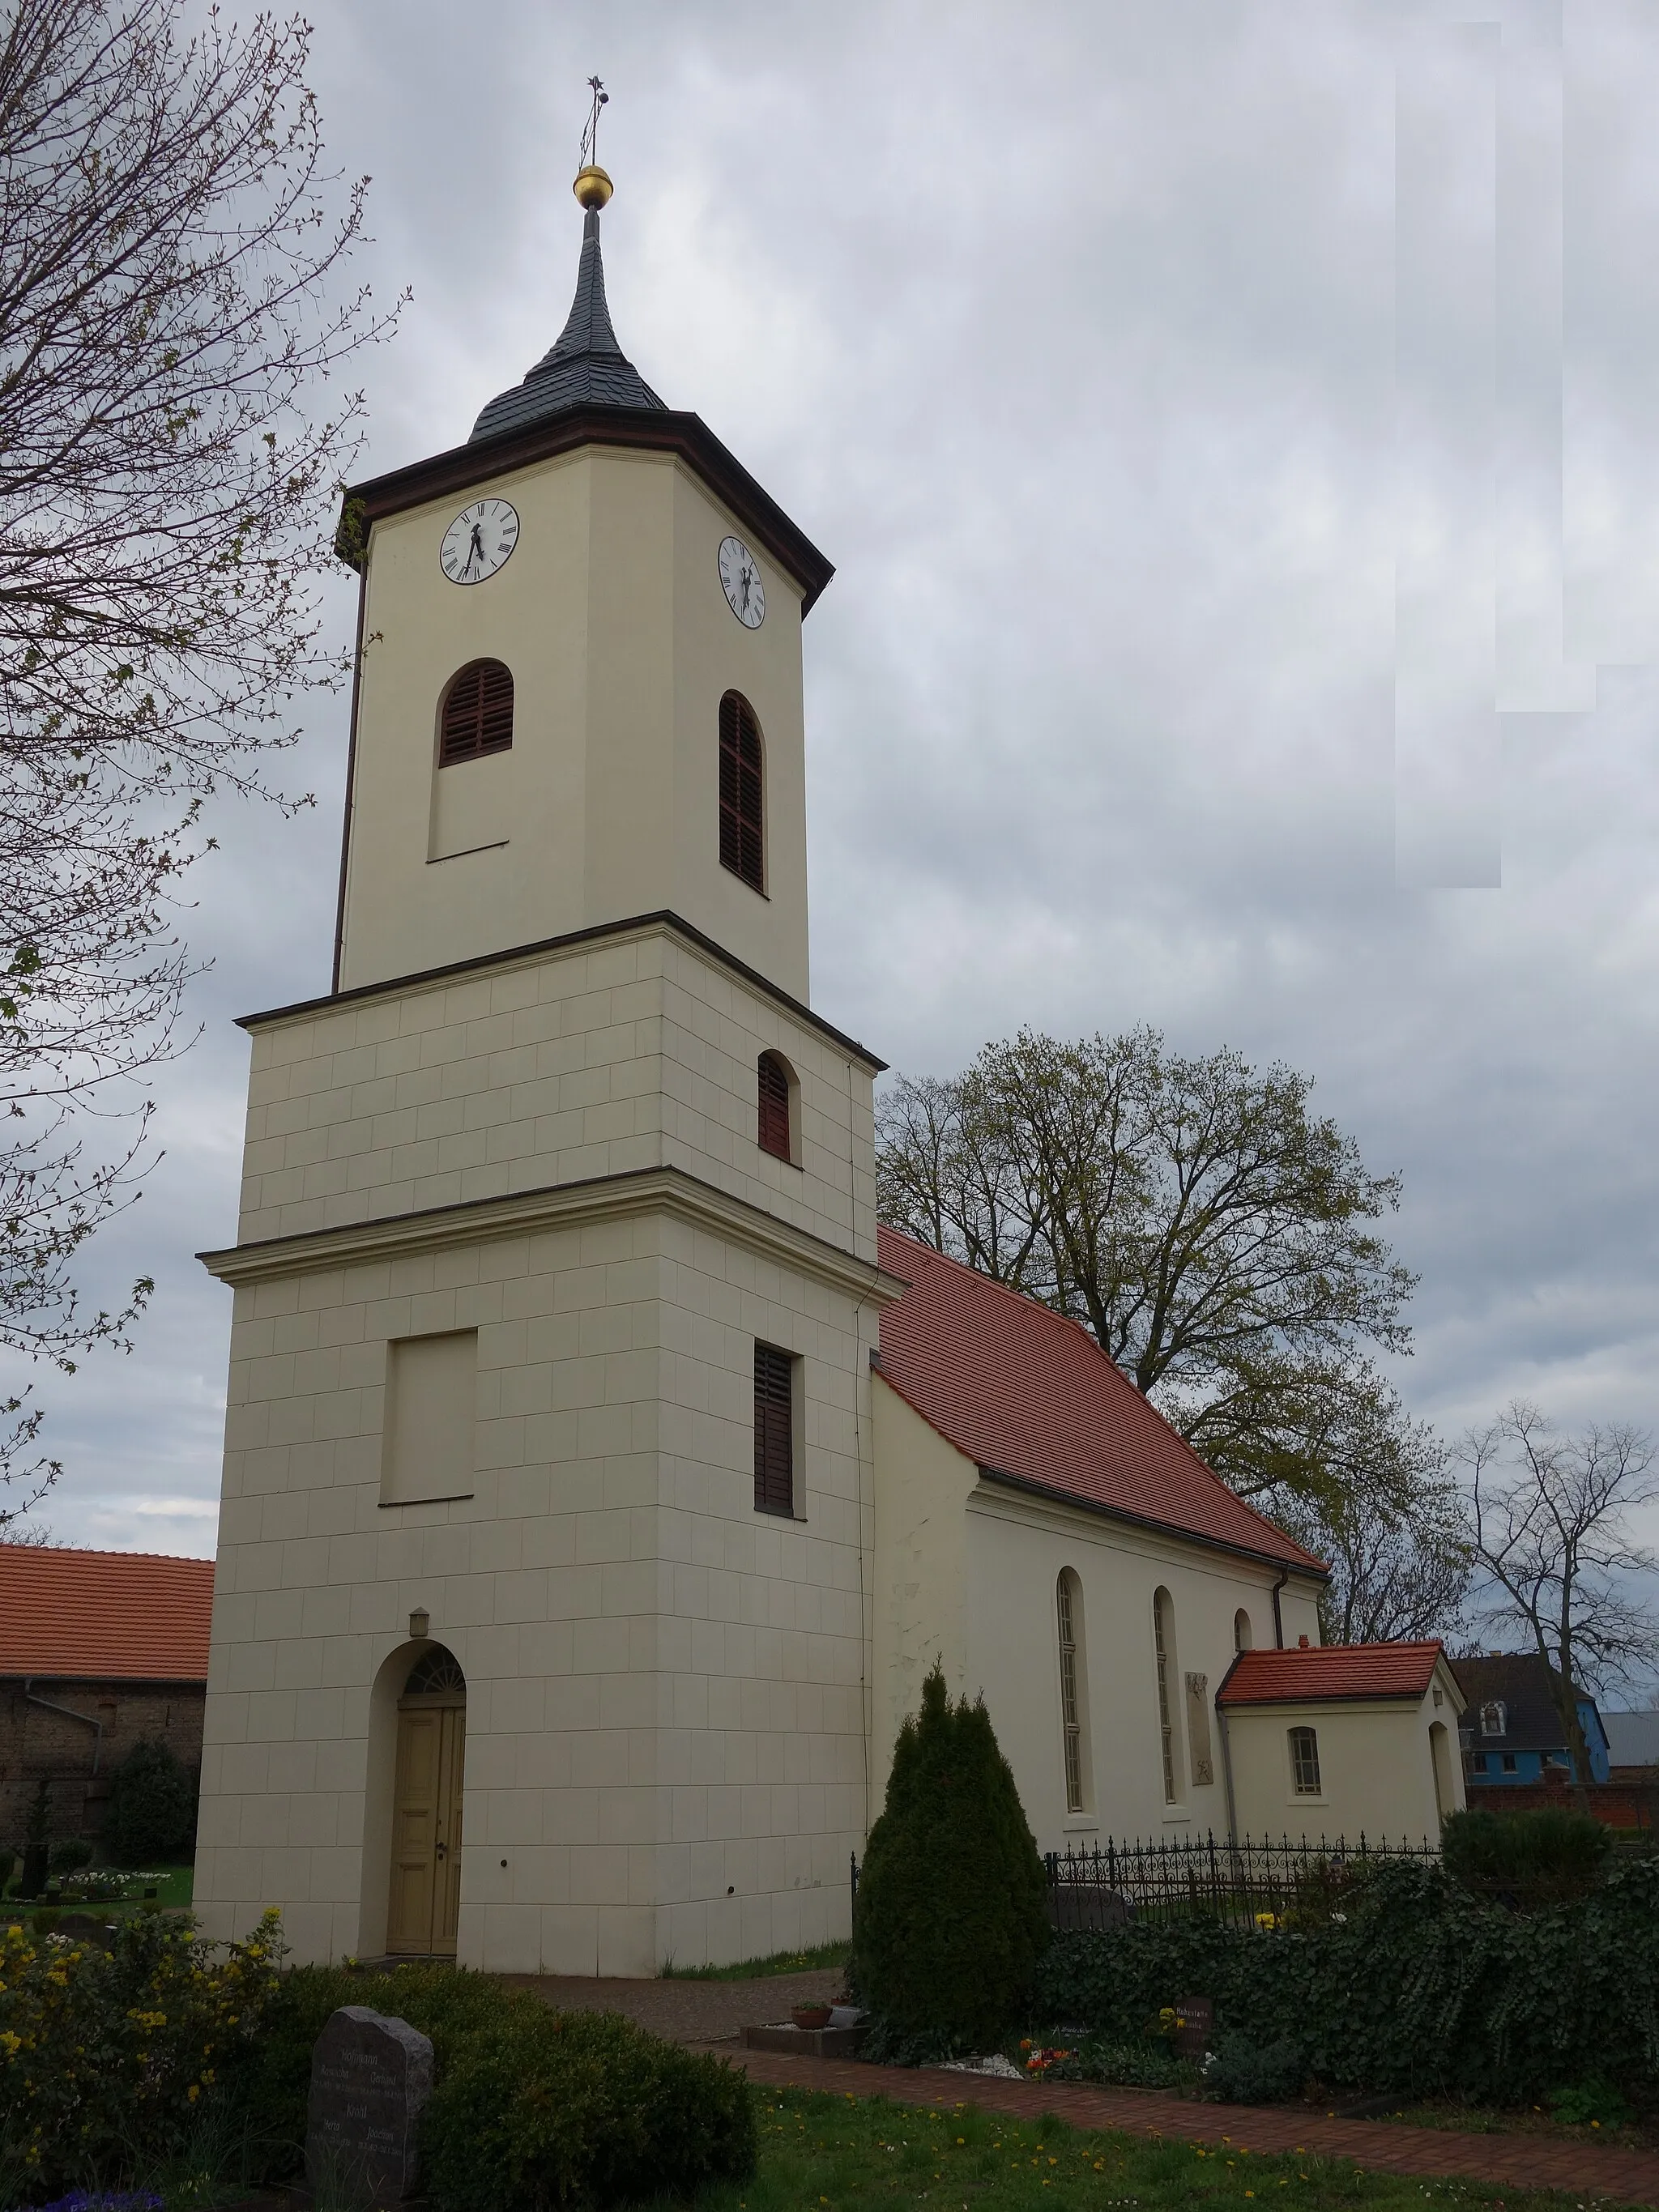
239 925 876 1263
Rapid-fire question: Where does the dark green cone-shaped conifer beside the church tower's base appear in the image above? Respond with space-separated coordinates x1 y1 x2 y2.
850 1665 1048 2057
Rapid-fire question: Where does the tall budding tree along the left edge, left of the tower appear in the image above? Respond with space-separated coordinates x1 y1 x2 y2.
0 0 396 1526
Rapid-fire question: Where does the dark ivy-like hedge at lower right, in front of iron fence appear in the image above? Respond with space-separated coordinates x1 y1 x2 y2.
1035 1858 1659 2103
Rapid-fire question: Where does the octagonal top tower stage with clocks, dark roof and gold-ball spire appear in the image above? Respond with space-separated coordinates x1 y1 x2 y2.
334 166 832 998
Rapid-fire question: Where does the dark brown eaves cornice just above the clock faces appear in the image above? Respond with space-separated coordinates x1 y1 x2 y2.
334 405 836 615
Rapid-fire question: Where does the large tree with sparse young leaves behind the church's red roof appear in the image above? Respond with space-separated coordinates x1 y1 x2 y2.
876 1029 1420 1511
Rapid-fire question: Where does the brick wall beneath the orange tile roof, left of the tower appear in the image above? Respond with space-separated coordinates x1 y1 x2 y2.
0 1679 206 1849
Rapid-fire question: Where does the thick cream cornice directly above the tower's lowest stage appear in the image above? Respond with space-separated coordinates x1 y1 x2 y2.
197 1168 905 1305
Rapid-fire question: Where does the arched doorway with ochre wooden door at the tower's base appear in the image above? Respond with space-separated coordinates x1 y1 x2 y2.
385 1643 467 1958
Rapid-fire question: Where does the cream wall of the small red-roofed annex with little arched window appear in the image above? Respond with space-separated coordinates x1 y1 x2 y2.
1228 1661 1465 1845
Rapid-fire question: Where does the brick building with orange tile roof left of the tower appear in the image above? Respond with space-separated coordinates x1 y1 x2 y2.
0 1544 212 1843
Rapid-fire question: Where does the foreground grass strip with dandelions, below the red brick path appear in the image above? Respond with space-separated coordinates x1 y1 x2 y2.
697 2091 1636 2212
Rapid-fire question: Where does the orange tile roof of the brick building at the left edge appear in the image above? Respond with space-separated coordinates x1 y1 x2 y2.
0 1544 212 1681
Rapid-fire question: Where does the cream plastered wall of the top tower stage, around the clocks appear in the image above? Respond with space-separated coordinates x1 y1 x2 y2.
341 447 808 999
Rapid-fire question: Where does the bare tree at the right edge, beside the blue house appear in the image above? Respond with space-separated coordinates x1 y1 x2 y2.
1458 1398 1659 1785
